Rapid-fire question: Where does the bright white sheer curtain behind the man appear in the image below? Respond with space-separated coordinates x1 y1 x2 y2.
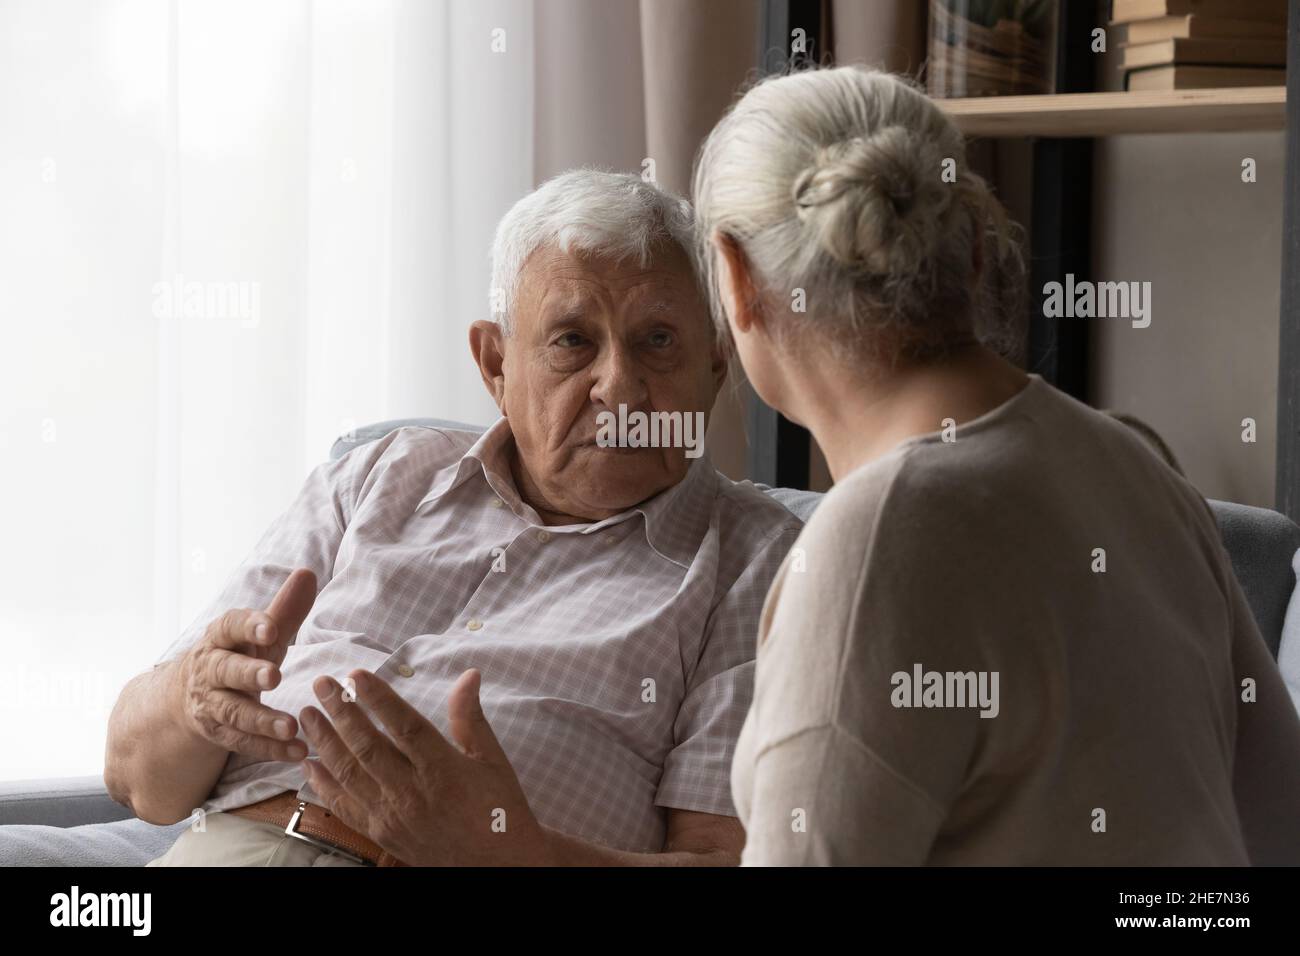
0 0 534 779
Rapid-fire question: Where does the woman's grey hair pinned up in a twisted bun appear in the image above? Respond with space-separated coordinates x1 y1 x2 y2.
693 66 1026 360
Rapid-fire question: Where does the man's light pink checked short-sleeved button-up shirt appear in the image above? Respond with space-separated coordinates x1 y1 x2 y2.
159 419 802 852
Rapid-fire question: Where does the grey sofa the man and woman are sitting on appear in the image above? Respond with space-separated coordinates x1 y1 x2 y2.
0 419 1300 866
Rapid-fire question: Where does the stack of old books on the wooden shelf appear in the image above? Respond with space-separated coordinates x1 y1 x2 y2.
1110 0 1287 90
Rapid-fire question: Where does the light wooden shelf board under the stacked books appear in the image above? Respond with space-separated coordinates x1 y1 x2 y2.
936 86 1287 137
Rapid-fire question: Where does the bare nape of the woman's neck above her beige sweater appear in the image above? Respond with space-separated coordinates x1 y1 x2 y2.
788 345 1028 481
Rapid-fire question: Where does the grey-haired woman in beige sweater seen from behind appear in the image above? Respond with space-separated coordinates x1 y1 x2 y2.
694 68 1300 865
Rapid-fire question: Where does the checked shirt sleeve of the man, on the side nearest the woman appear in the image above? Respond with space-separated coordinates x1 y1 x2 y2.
655 524 800 817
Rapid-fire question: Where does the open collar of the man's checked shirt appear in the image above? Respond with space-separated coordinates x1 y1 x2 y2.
420 418 718 568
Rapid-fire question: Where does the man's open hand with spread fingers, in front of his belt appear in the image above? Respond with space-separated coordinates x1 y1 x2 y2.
300 670 553 866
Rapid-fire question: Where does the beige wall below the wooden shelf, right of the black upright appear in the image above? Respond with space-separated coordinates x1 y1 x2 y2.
1089 133 1284 507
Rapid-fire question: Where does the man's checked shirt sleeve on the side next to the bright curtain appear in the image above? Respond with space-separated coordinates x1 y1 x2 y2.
153 429 416 667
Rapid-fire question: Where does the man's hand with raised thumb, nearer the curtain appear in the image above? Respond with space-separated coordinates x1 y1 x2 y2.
177 568 316 761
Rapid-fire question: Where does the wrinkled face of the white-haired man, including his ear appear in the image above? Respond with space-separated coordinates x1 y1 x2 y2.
471 246 725 523
